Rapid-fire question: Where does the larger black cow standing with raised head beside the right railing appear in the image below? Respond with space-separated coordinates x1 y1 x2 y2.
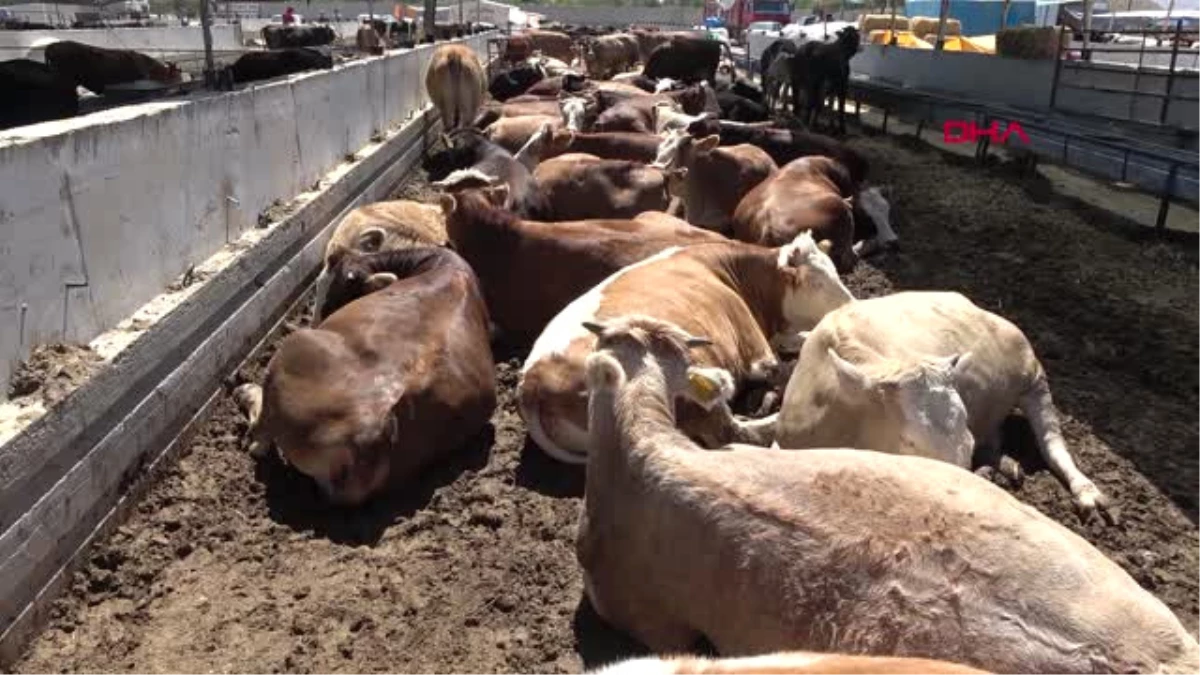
791 25 860 133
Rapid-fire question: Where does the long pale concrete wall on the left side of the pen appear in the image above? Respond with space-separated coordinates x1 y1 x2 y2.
0 34 488 398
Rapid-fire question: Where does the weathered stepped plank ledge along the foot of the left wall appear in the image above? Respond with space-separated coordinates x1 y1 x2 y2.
0 107 433 664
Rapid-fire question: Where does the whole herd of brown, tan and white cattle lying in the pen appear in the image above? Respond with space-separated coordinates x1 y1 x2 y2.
223 36 1200 675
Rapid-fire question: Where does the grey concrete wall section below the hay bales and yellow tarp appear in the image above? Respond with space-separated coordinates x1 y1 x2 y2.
850 44 1054 108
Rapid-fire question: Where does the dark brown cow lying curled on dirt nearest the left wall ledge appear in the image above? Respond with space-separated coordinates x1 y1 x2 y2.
231 246 496 506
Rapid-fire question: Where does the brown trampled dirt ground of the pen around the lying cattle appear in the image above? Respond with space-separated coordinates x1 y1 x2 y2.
17 132 1200 674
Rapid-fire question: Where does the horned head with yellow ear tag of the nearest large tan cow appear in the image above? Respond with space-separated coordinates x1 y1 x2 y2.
583 315 713 398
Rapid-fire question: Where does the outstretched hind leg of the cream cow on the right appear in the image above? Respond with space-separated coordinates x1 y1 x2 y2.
1020 374 1117 524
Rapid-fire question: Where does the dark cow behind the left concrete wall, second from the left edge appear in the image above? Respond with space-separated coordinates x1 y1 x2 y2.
44 40 181 94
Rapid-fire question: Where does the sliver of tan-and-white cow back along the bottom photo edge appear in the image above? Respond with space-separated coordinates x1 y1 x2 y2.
587 651 988 675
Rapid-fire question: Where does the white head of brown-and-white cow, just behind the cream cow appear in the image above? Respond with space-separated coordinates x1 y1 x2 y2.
778 232 854 334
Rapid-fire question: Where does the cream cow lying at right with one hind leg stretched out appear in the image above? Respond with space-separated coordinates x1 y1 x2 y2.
778 292 1109 516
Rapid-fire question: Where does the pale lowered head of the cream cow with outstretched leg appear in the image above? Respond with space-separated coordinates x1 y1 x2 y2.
828 347 974 466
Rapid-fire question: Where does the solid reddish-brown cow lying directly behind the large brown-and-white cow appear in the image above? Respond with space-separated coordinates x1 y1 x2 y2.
440 187 722 345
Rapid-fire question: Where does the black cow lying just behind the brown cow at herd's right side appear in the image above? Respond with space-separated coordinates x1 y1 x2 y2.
688 119 868 185
